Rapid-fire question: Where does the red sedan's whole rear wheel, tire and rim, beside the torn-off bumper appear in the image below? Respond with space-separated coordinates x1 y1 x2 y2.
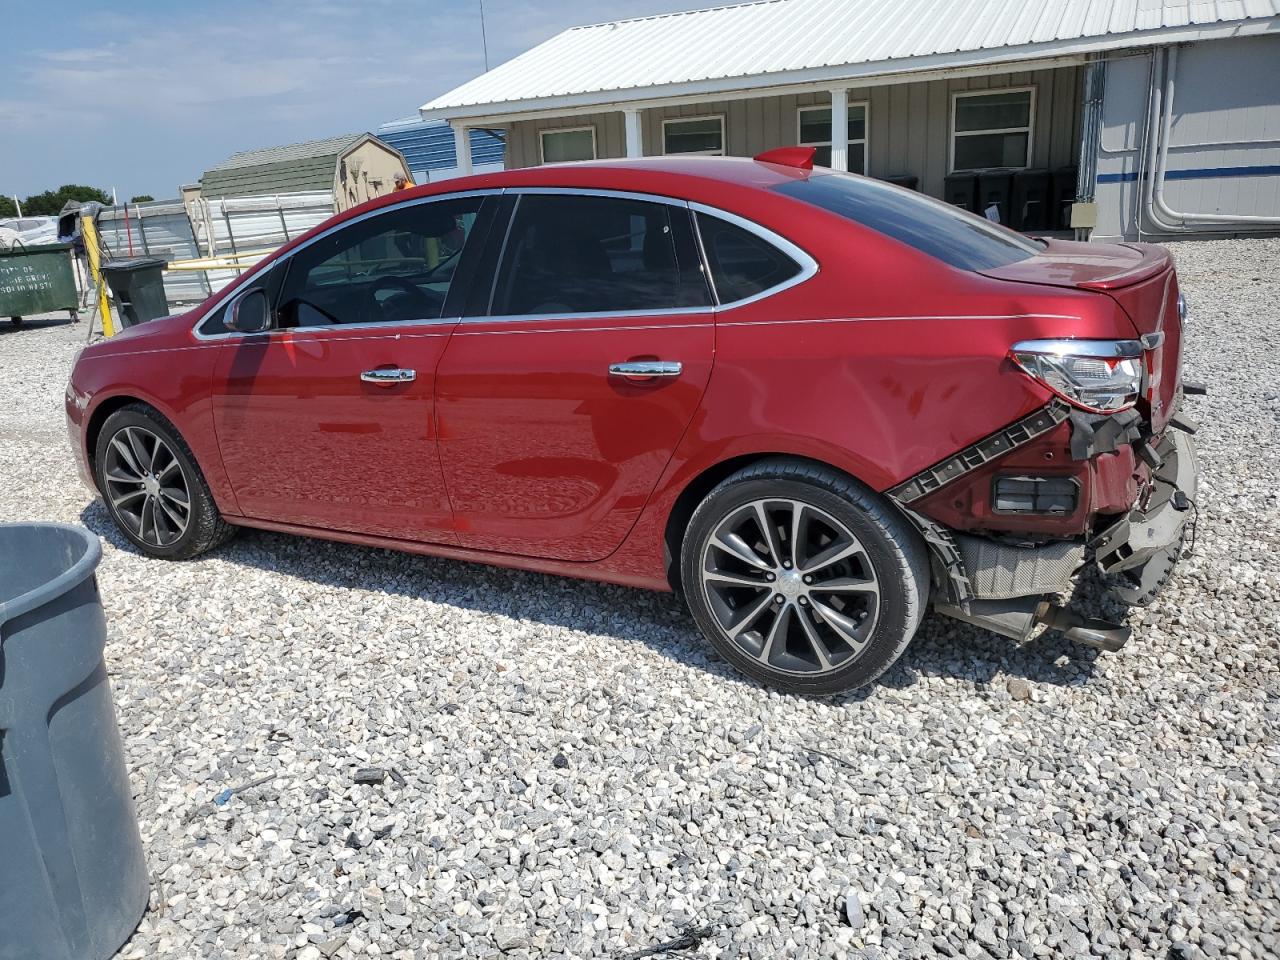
681 460 929 694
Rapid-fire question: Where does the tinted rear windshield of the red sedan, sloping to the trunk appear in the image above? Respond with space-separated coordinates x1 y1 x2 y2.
774 173 1041 270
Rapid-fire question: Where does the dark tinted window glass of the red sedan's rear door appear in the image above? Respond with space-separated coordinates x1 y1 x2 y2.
492 193 709 316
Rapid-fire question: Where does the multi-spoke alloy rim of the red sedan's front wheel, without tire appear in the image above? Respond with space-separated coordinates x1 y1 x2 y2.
102 426 191 547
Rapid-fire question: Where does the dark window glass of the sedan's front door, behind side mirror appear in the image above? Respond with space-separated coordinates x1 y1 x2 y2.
276 196 484 326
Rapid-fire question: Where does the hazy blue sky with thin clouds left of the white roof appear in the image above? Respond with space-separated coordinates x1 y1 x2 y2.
0 0 713 200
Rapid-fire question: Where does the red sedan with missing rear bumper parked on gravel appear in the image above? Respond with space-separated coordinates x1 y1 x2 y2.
67 148 1196 692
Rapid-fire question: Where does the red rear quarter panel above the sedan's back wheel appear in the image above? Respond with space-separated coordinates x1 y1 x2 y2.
599 204 1132 586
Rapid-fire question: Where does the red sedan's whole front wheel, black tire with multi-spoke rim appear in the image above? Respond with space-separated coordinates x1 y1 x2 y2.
93 403 236 559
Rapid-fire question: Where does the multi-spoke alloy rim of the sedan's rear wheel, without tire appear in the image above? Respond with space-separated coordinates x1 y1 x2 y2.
701 499 879 675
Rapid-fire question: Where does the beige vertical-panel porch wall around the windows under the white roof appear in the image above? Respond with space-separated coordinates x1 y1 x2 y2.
507 67 1084 196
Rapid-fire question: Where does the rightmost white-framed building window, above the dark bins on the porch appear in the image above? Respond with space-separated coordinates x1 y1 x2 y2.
951 87 1036 170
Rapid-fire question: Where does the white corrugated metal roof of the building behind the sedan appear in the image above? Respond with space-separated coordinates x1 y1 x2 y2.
422 0 1280 115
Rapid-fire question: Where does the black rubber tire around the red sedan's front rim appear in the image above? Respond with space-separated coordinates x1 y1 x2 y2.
93 403 237 561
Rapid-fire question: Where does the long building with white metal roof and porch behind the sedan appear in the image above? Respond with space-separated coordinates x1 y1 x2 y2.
421 0 1280 238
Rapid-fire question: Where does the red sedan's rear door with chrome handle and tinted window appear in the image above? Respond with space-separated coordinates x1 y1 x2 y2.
436 191 716 561
